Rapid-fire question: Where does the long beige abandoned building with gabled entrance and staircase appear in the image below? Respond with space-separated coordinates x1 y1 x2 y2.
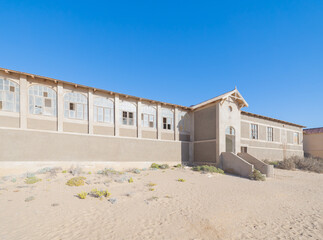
0 68 304 175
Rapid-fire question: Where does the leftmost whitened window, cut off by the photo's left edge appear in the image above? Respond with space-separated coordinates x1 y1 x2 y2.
0 78 20 112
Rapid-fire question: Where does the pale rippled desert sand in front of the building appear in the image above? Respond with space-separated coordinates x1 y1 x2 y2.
0 165 323 240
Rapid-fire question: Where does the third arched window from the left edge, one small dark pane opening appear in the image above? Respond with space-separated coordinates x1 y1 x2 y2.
64 92 88 120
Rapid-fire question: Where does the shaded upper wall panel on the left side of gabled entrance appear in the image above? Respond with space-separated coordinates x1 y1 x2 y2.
194 105 216 141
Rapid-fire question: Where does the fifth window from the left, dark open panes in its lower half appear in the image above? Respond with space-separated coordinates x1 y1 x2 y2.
119 100 137 126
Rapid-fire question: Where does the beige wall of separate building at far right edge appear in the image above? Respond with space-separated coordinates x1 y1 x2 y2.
304 133 323 158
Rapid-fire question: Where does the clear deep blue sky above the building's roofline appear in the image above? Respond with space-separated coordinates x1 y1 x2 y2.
0 0 323 127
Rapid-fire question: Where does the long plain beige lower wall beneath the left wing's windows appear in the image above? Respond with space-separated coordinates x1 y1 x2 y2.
0 129 188 163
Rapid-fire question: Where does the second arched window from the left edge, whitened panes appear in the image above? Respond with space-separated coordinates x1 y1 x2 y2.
28 85 56 116
